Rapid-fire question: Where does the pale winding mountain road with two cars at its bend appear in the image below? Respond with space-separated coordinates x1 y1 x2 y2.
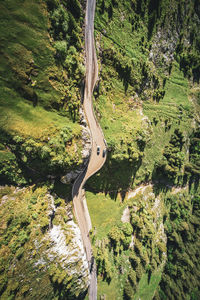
72 0 106 300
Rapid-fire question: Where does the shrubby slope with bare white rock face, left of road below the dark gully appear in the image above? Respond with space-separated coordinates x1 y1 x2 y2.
0 186 90 300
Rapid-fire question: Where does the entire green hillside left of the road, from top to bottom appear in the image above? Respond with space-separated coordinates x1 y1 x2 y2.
0 0 89 299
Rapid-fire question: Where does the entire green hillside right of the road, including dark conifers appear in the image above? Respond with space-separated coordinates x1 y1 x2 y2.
87 1 200 299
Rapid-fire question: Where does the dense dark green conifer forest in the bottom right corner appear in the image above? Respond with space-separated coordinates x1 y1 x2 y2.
155 188 200 299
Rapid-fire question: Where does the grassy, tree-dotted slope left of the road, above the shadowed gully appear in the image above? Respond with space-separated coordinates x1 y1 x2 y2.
0 0 83 184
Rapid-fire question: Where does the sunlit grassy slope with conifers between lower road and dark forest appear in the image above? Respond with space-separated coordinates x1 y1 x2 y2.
86 186 166 299
